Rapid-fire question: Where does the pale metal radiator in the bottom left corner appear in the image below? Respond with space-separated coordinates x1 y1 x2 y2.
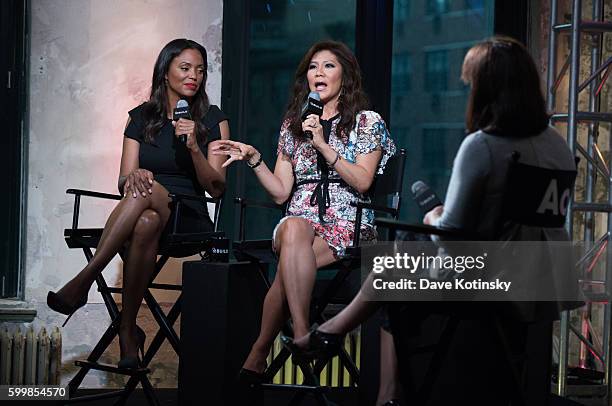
0 326 62 385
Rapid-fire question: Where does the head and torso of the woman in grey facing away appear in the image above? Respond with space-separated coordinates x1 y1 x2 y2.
423 37 575 240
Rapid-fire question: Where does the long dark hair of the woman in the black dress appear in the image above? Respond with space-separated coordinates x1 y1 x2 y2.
143 38 210 142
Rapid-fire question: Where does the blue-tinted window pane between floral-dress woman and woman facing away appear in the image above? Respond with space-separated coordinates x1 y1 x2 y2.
389 0 494 221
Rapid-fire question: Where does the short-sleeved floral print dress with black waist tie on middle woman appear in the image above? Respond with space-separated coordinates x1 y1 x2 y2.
278 111 395 258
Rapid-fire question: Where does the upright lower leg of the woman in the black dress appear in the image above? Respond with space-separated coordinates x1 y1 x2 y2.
119 209 169 357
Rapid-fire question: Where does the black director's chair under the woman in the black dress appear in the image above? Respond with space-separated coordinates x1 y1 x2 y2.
64 189 227 405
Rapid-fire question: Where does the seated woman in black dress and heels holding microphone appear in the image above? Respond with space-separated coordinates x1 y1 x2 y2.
47 39 229 368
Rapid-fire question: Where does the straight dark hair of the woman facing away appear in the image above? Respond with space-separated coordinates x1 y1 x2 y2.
461 36 550 137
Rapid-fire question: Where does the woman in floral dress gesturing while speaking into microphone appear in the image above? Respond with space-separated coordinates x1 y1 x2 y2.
214 41 395 382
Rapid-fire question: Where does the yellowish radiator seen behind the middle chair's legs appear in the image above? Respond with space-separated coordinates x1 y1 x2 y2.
268 329 361 387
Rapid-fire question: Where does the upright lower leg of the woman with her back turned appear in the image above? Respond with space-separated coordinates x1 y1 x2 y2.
376 329 401 405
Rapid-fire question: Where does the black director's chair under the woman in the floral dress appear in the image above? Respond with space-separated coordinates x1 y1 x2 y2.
233 149 406 405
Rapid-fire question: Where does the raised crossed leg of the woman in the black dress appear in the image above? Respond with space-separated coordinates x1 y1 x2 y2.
57 182 170 304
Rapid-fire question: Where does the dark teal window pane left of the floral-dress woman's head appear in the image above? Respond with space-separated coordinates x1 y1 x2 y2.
245 0 356 238
